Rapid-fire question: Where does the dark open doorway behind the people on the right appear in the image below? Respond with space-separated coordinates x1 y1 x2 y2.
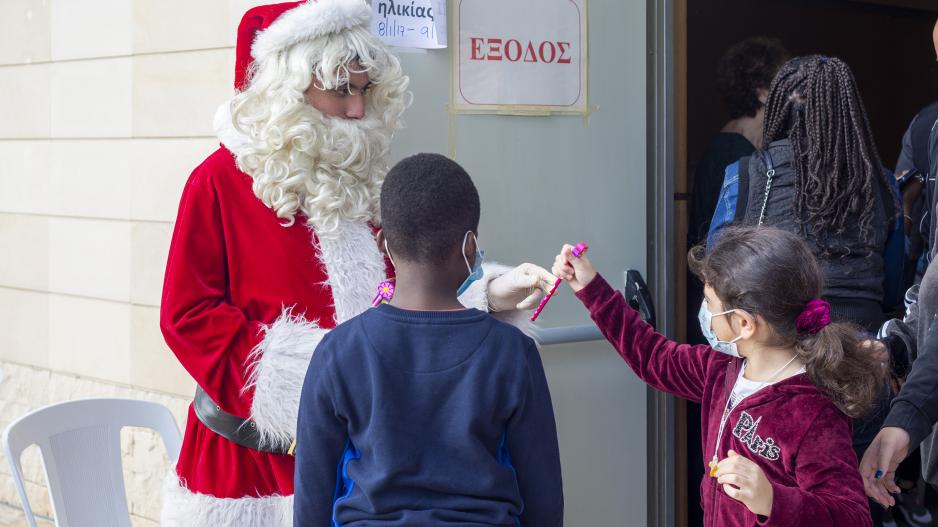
673 0 938 526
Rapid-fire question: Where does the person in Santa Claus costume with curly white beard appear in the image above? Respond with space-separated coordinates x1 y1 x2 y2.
160 0 553 527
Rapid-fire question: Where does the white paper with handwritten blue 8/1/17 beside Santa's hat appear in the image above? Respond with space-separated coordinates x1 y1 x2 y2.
371 0 446 49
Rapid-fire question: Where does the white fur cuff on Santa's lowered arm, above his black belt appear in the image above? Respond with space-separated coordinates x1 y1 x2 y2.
244 308 329 448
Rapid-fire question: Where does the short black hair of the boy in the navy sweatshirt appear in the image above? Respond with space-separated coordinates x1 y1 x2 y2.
381 154 480 263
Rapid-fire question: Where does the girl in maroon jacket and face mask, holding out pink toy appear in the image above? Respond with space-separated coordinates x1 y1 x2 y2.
553 227 882 527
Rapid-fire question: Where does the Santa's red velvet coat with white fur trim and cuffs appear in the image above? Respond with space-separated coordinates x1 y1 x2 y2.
160 130 523 527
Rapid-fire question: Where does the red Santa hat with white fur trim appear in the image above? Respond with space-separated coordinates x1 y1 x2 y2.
235 0 371 90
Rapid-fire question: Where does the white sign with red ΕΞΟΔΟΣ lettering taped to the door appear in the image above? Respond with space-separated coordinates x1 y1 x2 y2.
453 0 587 113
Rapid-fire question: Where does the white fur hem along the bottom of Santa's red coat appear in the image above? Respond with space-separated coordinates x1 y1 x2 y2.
160 472 293 527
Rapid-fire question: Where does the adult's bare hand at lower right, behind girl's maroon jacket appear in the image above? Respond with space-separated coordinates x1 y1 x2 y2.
860 426 911 507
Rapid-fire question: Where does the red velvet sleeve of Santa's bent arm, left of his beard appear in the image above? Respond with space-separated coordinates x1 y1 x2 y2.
160 165 262 417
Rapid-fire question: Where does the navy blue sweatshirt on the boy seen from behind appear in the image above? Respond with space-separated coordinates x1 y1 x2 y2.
294 304 563 527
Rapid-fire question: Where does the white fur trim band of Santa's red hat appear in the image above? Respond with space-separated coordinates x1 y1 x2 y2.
251 0 371 60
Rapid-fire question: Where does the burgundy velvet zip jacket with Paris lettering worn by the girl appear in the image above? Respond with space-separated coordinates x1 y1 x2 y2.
577 275 872 527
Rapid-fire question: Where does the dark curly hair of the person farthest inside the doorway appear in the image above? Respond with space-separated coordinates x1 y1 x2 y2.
717 37 790 119
